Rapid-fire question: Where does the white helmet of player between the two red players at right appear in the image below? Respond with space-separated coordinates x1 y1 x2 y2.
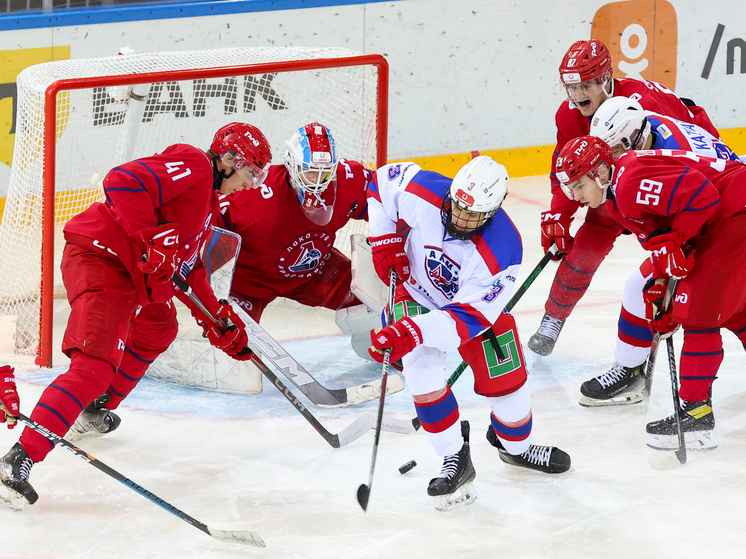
590 96 650 157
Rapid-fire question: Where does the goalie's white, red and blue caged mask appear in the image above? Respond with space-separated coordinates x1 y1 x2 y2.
284 122 339 225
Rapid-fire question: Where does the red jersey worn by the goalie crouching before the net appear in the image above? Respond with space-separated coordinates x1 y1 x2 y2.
224 159 371 299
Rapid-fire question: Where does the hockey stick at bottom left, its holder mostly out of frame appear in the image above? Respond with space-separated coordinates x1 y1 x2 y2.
18 413 265 547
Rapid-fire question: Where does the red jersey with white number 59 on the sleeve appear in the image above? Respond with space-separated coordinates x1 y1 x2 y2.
604 150 746 242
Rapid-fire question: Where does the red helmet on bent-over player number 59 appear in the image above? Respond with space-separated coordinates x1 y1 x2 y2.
554 136 614 200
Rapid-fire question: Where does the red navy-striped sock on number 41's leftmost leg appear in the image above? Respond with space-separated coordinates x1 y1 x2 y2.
20 351 114 462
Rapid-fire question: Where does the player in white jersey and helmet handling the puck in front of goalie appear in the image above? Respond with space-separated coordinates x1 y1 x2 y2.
368 156 570 510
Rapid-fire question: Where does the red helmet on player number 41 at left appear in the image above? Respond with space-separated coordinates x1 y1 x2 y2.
210 122 272 186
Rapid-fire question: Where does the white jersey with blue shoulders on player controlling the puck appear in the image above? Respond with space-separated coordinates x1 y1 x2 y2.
368 163 523 351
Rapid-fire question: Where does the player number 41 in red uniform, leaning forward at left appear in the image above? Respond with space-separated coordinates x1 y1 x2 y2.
0 123 272 506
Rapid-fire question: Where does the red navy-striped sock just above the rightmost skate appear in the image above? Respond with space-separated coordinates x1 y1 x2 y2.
679 328 723 402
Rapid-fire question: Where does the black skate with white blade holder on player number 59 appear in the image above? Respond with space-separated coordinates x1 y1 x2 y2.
645 400 717 451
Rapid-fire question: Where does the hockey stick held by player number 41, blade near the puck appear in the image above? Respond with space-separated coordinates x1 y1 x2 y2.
171 274 419 448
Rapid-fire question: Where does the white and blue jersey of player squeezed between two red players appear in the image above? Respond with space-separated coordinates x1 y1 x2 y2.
645 111 740 161
